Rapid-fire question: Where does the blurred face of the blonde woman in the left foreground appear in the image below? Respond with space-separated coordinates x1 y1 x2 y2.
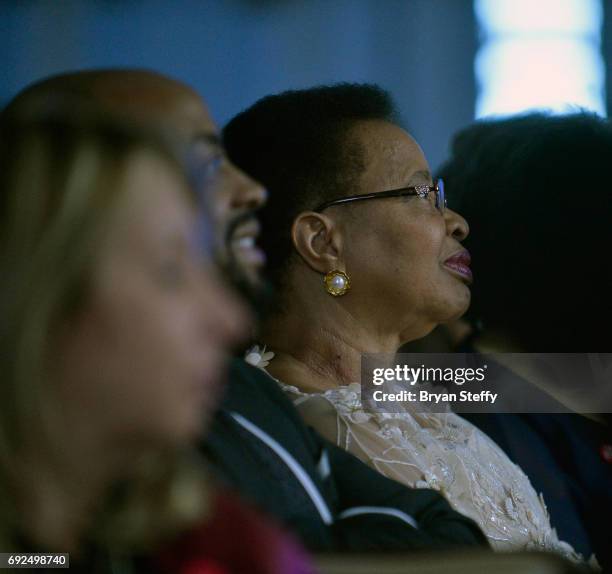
58 151 248 445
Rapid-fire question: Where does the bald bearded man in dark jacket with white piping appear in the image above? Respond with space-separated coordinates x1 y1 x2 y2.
3 70 486 552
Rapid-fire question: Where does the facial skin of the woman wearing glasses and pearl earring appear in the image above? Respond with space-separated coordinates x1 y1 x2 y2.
342 121 471 340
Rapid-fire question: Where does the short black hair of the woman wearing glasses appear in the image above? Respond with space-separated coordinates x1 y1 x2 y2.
223 83 399 288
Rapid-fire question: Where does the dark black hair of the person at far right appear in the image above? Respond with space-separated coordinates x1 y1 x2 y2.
439 113 612 352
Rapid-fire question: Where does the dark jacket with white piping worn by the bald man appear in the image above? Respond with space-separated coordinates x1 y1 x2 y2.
202 359 487 551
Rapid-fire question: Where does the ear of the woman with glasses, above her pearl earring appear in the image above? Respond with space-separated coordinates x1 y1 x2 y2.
291 211 342 273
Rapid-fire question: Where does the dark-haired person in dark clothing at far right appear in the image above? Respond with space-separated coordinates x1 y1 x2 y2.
439 113 612 569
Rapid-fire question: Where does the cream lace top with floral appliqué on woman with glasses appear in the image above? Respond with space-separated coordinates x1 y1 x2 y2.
247 348 582 561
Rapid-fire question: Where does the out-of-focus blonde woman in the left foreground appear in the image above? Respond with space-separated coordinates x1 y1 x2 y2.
0 109 314 572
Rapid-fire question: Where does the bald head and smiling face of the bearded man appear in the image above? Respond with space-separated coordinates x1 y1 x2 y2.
2 69 265 283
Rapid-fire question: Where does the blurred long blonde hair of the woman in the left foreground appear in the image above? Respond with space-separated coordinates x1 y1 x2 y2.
0 110 206 552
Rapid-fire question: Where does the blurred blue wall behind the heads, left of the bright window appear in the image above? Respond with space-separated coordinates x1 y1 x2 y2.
0 0 476 171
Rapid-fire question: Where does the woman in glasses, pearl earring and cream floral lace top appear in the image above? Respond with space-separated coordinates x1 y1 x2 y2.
224 84 576 558
